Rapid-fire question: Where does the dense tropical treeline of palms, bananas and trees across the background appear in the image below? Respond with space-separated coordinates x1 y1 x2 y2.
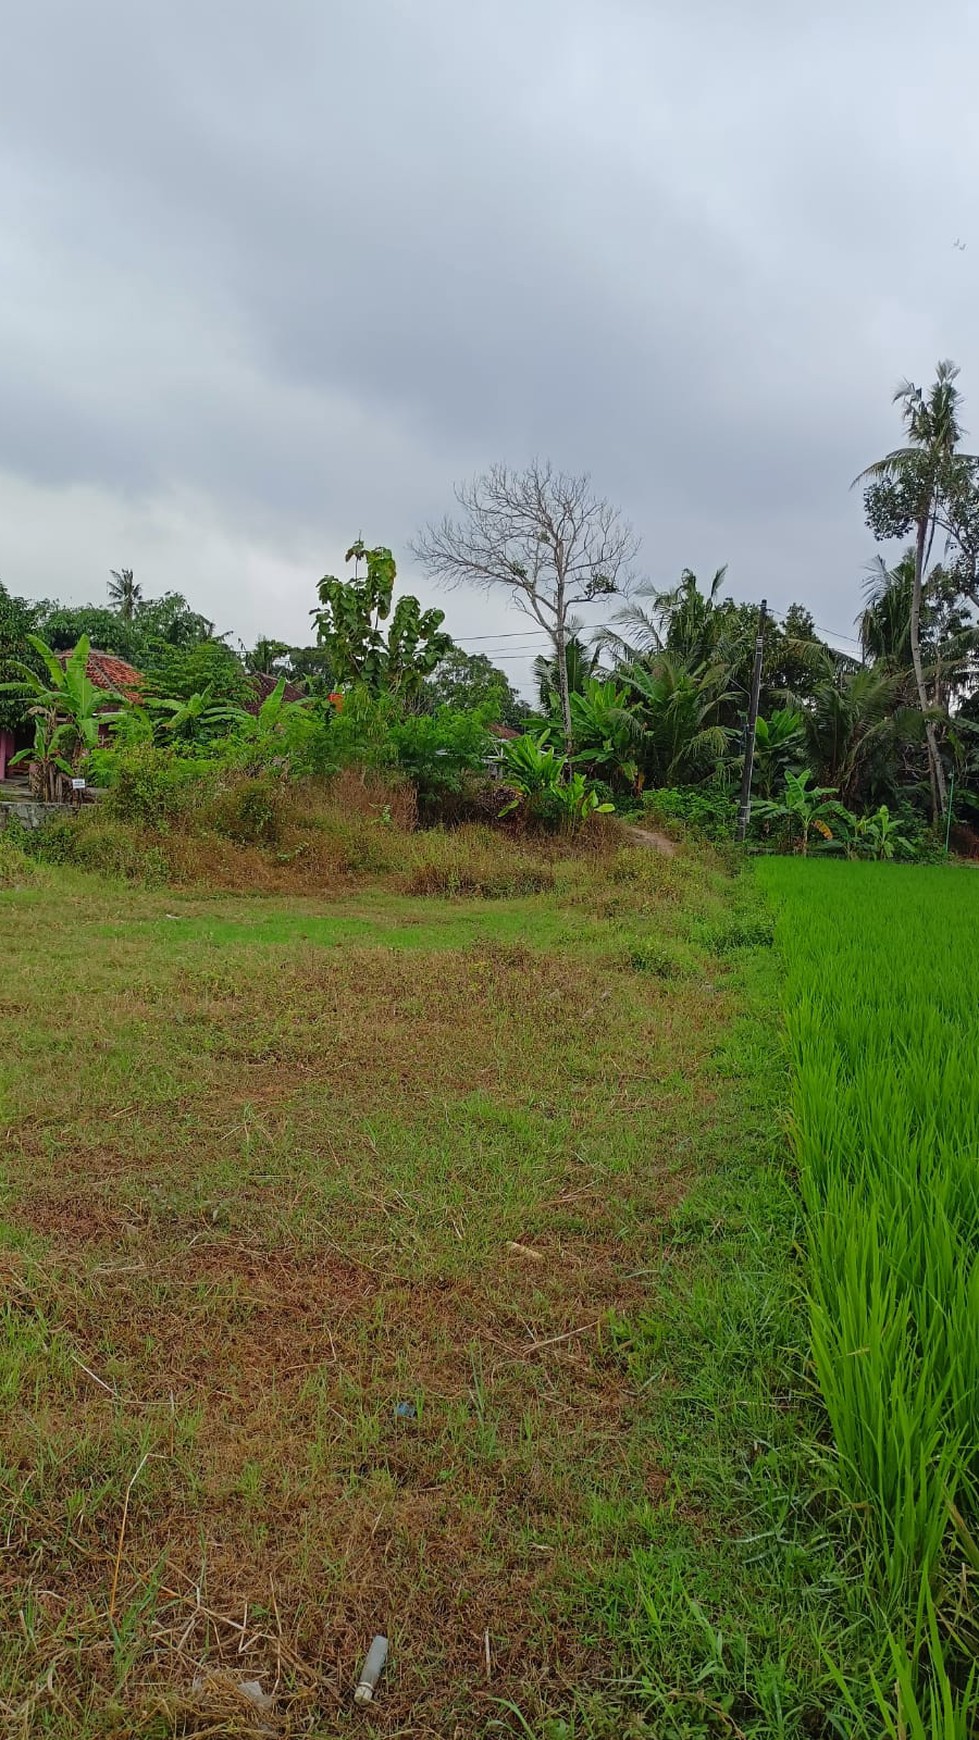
0 364 979 856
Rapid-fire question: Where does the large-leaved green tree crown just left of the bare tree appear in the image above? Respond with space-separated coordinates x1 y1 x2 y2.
313 539 452 699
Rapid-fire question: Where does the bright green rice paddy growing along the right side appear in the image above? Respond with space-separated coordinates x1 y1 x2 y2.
758 860 979 1740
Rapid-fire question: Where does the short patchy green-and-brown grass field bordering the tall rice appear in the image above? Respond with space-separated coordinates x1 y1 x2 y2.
0 847 796 1740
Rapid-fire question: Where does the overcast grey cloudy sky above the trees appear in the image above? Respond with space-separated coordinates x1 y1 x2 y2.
0 0 979 680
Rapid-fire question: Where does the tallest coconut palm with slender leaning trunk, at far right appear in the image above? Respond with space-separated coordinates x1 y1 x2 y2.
854 362 979 816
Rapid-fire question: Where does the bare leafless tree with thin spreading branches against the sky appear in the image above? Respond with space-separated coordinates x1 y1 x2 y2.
412 459 638 748
